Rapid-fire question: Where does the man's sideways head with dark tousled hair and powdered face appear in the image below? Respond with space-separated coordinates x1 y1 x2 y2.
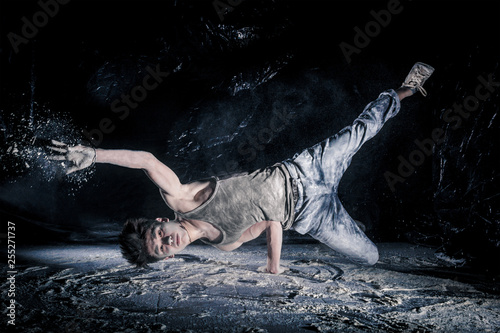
119 218 191 267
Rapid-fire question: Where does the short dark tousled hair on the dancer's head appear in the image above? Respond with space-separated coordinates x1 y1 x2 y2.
118 218 161 268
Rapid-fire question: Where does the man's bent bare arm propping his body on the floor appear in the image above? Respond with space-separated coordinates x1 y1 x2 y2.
218 221 284 274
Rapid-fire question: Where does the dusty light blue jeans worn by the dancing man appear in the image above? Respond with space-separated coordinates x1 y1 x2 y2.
283 90 400 265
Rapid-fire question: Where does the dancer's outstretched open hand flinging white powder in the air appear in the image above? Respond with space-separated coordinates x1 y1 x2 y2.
48 140 96 175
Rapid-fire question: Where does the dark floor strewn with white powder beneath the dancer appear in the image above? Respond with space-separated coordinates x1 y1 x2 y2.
2 243 500 332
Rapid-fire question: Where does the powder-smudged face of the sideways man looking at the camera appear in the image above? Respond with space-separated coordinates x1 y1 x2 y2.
146 219 191 259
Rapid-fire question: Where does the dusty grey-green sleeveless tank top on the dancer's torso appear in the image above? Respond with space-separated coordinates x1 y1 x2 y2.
160 163 295 245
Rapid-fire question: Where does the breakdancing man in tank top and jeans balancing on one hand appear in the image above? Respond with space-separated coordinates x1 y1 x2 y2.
51 63 434 274
